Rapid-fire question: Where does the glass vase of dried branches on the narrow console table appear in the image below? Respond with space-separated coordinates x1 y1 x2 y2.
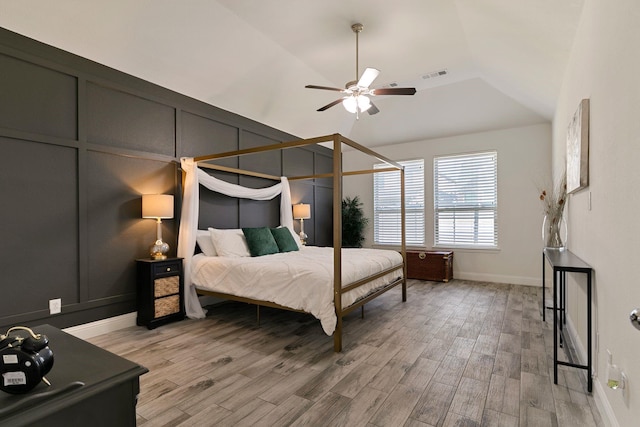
540 173 567 250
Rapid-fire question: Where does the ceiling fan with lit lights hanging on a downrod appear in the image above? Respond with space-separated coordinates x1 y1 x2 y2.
305 24 416 119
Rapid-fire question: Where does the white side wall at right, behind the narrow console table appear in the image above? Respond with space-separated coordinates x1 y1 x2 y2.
553 0 640 426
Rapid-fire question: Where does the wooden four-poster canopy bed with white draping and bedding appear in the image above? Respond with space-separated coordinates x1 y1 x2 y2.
178 134 407 352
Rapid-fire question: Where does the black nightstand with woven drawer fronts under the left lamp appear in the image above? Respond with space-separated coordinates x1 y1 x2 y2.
136 258 185 329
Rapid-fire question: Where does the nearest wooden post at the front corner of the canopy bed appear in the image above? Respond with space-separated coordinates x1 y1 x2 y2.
333 134 342 353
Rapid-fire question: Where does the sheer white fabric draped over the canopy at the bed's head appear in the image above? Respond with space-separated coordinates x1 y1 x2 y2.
178 157 295 319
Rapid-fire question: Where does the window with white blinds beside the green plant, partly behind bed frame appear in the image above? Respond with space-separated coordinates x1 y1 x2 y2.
373 159 424 245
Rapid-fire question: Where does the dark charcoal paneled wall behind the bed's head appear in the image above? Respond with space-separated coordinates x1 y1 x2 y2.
0 29 332 331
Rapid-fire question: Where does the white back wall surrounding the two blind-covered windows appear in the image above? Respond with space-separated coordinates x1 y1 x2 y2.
343 124 551 286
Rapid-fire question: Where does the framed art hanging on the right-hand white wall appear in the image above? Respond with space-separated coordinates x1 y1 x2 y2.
567 99 589 193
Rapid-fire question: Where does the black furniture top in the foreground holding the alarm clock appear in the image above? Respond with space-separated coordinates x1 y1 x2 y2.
0 325 147 427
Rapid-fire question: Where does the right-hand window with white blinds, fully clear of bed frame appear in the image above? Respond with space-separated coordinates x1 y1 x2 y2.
433 151 498 248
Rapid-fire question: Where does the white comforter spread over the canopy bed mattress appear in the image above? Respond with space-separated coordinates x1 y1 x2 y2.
191 246 402 335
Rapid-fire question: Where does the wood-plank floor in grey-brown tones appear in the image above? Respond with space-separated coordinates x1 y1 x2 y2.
90 280 603 427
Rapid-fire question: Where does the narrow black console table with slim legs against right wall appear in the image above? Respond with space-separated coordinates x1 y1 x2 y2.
542 249 593 392
